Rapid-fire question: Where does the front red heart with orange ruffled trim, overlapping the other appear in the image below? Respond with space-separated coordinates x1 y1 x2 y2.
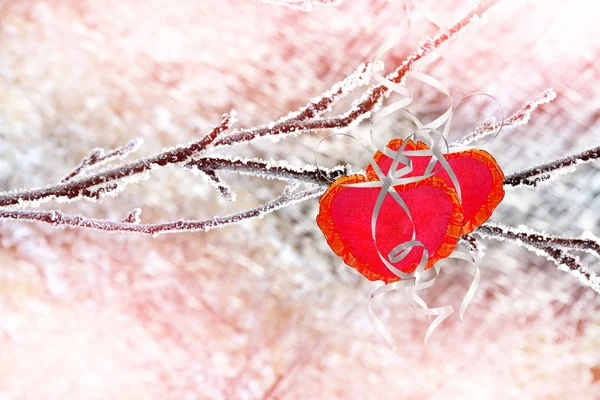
317 175 463 283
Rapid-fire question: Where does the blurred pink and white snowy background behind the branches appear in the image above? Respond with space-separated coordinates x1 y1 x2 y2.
0 0 600 400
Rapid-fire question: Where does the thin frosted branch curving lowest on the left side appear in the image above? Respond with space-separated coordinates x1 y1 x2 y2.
0 187 324 236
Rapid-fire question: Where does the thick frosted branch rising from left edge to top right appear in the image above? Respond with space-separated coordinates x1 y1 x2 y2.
0 4 490 211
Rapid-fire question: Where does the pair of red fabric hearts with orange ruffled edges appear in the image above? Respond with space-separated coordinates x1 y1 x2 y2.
317 139 504 283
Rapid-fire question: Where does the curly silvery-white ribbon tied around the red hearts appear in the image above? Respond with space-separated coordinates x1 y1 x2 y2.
315 2 503 352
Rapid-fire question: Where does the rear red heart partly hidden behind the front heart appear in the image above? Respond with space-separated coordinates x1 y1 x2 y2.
367 139 504 235
